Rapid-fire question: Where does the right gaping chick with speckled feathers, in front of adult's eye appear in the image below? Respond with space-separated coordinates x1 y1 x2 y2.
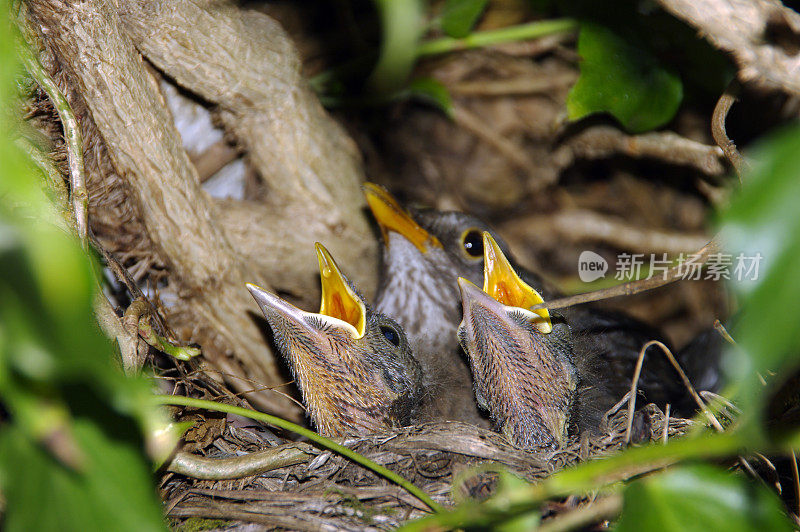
458 232 615 449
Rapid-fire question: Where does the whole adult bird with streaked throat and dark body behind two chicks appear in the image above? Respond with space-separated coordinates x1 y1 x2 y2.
364 183 717 422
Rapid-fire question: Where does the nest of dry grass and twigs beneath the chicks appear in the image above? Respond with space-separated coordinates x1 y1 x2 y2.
162 403 693 530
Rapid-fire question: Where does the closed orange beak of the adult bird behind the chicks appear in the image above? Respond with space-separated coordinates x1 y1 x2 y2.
362 183 442 253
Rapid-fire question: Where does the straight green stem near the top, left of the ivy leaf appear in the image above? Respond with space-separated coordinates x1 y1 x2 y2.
417 18 578 57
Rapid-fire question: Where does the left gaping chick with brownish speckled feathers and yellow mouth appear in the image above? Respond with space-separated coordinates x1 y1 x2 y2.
247 243 423 436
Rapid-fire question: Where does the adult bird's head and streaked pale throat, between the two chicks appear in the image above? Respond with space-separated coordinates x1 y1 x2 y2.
364 183 520 426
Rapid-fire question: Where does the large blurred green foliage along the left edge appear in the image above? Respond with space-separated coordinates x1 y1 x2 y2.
0 1 164 531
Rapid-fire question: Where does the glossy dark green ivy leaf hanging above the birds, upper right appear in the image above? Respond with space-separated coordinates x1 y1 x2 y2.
567 22 683 133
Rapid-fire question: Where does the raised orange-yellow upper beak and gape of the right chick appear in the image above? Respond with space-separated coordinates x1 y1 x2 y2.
483 231 553 334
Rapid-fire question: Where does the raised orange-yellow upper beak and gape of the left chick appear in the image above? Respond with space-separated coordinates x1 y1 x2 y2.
315 242 367 338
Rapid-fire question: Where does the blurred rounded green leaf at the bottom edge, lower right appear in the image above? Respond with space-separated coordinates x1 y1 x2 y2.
616 465 793 532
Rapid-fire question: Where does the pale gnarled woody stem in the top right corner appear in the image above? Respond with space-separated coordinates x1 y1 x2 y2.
659 0 800 94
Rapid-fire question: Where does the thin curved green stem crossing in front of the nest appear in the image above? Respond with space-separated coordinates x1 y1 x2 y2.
154 395 443 513
